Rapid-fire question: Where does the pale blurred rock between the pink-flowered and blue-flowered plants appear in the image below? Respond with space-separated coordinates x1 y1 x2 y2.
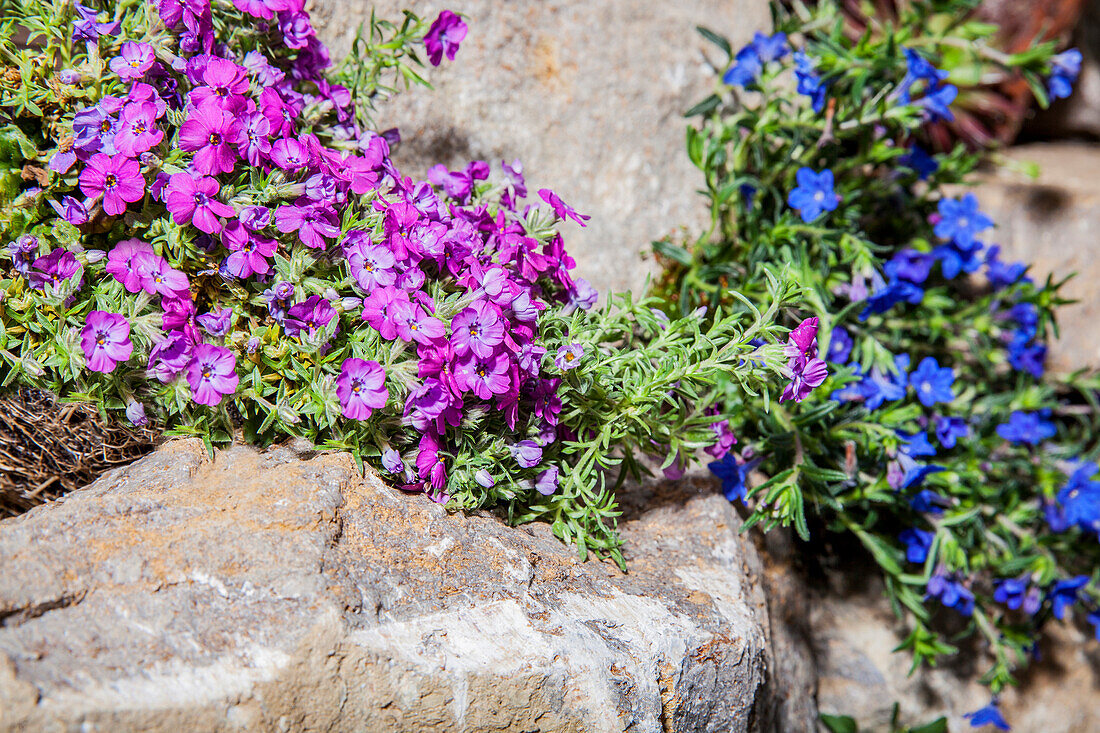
312 0 770 293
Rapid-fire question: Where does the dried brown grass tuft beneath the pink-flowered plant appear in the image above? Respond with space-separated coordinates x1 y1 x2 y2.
0 389 157 518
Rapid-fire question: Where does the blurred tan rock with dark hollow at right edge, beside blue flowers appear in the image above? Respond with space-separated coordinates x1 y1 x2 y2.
978 143 1100 372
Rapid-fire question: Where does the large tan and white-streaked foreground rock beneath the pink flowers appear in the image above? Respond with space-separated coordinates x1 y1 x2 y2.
0 441 796 731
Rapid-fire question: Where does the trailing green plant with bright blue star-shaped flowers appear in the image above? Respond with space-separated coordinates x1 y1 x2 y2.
655 0 1100 725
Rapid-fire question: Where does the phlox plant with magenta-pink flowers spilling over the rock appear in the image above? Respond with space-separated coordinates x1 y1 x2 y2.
0 0 818 565
